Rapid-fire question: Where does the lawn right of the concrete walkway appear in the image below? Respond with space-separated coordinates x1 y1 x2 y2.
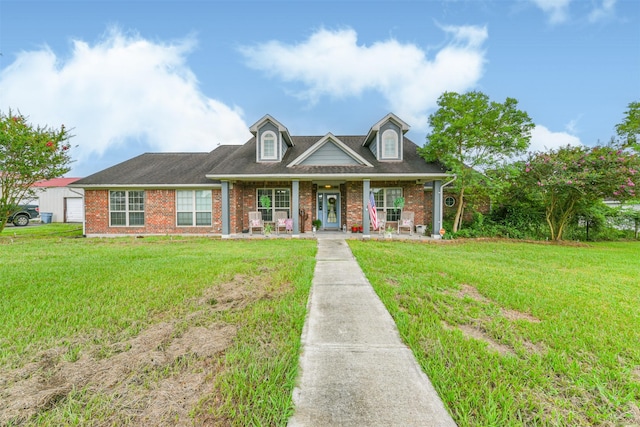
349 240 640 426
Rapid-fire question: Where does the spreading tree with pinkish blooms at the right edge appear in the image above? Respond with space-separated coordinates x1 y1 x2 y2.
516 146 640 241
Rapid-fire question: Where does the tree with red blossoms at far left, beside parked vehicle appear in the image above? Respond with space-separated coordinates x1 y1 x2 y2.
0 110 71 232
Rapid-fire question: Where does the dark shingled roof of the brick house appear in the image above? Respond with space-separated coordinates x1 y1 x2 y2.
72 136 446 187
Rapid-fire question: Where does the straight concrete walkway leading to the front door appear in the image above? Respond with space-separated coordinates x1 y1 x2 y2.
288 238 455 427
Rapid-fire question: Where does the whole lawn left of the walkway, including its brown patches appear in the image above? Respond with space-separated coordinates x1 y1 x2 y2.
0 224 316 426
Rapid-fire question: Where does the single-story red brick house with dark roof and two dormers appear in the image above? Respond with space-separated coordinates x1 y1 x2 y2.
71 114 452 238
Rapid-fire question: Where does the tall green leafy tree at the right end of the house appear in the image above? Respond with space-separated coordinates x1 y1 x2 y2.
418 92 534 232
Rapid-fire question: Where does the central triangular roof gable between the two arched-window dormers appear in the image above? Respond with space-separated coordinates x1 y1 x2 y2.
287 132 373 167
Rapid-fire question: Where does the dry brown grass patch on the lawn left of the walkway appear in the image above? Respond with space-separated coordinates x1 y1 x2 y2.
0 280 244 426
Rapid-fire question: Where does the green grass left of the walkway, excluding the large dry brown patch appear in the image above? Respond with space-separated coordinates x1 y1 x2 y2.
0 224 316 425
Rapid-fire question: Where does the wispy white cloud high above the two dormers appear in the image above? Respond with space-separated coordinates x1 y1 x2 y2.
241 26 488 129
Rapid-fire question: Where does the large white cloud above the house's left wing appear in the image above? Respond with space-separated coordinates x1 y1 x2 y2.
0 29 251 174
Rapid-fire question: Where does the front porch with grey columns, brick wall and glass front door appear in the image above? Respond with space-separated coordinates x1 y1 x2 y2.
220 178 446 238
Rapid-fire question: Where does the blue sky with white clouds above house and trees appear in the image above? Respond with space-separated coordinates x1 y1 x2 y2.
0 0 640 176
